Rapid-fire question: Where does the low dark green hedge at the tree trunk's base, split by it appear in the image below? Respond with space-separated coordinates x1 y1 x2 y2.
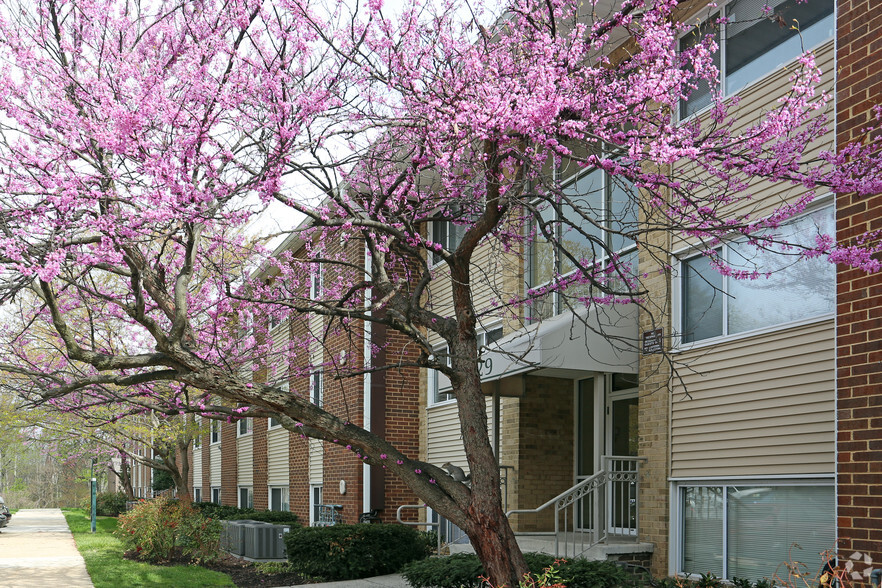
402 553 634 588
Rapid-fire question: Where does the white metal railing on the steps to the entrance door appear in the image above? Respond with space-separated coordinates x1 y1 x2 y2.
506 456 646 557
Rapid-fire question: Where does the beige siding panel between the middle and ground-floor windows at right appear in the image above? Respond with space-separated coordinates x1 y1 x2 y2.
671 319 835 478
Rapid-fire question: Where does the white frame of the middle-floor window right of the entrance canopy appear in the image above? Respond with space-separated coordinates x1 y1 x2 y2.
671 202 836 352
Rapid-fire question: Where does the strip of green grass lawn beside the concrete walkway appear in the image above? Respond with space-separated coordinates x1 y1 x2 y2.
63 508 235 588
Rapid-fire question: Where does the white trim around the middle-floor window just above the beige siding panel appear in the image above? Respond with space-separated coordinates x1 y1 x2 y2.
671 200 836 353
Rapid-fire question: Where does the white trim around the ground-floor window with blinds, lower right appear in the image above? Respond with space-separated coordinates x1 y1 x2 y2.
668 474 836 575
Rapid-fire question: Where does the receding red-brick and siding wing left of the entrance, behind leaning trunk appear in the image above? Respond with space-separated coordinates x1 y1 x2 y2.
191 224 419 524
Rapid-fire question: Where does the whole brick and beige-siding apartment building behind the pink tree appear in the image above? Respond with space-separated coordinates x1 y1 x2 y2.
192 0 882 579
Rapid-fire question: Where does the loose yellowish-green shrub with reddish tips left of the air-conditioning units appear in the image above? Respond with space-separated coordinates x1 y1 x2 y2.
116 497 221 562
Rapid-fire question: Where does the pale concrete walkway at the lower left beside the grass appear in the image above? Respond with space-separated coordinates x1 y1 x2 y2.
0 508 93 588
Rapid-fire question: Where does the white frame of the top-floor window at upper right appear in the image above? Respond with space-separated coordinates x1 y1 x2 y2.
676 0 836 122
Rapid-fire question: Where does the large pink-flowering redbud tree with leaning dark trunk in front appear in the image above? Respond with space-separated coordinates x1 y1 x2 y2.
0 0 882 585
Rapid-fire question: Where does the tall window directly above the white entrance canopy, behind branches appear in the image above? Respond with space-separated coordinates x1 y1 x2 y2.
526 169 637 320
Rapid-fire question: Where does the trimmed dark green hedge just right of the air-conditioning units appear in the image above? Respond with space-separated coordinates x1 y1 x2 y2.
285 525 428 580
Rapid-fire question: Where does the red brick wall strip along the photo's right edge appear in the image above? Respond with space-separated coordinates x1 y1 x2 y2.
836 0 882 562
